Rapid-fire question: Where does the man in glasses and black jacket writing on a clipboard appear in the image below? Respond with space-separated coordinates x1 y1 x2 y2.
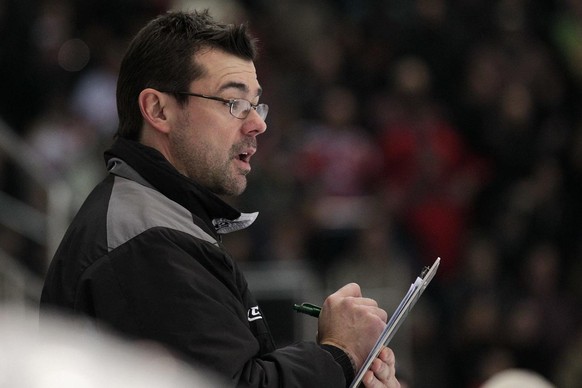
41 12 399 387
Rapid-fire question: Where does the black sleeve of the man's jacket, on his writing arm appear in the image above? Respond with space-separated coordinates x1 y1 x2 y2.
81 229 353 388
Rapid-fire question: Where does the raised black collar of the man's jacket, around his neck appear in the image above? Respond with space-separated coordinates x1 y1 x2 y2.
105 138 258 234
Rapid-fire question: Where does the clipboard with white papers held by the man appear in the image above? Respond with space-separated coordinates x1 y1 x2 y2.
350 257 441 388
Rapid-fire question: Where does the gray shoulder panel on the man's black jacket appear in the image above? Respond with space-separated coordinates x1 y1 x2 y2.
107 176 218 251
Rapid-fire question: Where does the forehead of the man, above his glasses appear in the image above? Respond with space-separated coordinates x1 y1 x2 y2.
193 49 261 95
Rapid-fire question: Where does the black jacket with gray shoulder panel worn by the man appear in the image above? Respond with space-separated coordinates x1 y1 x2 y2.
41 139 353 387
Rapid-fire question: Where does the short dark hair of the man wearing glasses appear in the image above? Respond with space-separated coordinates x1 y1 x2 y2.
117 10 256 140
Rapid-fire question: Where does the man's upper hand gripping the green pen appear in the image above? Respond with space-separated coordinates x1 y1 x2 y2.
318 283 388 371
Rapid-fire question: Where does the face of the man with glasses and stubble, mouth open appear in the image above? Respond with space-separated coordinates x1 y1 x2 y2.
169 49 267 195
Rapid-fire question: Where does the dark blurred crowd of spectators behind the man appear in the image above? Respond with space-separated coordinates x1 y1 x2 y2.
0 0 582 388
